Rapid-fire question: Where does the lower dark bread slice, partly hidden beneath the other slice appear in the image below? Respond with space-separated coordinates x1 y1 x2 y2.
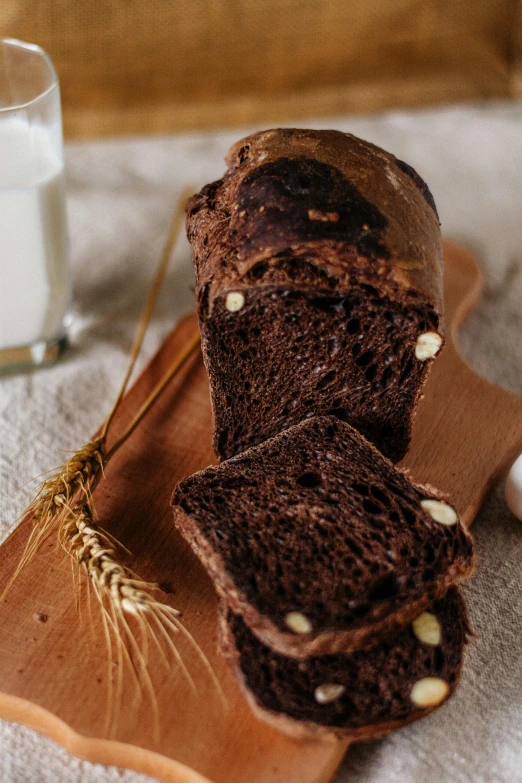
219 587 469 741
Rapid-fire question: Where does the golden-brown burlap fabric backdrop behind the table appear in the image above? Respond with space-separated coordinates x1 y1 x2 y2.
0 0 522 136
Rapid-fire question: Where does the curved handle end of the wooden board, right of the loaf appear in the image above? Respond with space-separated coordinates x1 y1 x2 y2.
402 241 522 525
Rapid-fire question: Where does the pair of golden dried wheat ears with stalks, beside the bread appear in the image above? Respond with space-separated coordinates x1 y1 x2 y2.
0 189 223 733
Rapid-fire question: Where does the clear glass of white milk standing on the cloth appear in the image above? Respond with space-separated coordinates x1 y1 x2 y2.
0 38 71 373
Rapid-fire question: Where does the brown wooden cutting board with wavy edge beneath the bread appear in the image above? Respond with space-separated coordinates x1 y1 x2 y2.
0 242 522 783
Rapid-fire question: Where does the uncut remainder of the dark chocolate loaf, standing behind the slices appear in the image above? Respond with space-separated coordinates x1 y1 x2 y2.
187 129 443 462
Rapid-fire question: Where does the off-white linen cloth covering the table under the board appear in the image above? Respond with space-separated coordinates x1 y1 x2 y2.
0 103 522 783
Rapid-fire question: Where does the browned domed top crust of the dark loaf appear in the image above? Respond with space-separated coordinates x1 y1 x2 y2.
187 128 442 322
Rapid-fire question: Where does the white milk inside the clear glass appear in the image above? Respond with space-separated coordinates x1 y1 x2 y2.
0 117 70 349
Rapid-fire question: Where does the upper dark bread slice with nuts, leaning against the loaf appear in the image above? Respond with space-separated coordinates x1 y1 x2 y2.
173 417 473 657
